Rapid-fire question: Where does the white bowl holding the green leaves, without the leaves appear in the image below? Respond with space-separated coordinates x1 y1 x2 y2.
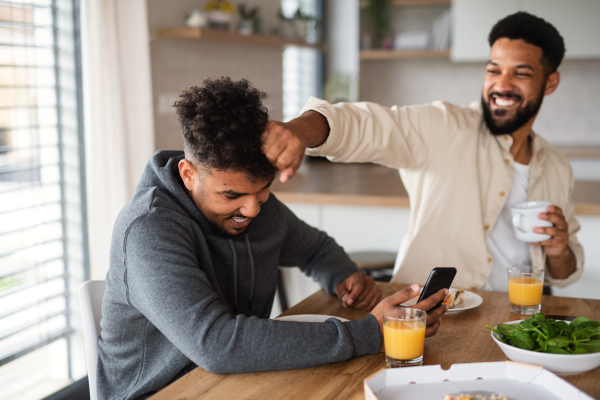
491 320 600 374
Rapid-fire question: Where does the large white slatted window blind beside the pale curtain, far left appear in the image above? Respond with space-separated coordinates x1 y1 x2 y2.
0 0 89 399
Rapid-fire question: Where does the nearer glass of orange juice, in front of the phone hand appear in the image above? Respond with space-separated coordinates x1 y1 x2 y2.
383 307 427 368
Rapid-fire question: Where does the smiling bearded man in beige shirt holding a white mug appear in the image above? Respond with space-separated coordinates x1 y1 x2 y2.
263 12 584 291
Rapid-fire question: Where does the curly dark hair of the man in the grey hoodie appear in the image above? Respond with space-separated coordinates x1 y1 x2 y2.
173 77 277 180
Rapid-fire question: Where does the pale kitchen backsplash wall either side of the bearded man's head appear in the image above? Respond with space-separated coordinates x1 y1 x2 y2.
360 59 600 146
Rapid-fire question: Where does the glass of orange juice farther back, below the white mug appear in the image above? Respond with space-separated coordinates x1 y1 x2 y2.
508 266 544 315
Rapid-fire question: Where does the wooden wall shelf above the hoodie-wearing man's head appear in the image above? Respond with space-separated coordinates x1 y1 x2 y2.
153 28 319 49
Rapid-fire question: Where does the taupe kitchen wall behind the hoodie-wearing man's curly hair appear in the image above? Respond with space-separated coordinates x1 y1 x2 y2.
148 0 283 149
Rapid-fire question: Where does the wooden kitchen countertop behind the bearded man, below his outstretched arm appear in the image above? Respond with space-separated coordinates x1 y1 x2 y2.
272 157 600 215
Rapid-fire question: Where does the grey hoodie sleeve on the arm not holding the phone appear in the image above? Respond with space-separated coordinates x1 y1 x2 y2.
277 200 359 295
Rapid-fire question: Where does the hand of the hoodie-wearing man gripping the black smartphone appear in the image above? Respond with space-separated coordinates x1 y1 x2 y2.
371 283 448 352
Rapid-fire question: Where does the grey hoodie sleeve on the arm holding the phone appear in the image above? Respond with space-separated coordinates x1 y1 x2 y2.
124 211 381 373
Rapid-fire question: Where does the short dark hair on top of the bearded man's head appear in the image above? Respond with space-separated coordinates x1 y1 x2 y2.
488 11 565 75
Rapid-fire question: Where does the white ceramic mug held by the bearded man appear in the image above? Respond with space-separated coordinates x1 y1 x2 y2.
510 201 553 243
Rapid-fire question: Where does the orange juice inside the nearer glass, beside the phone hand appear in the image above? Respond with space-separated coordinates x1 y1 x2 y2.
383 320 425 360
